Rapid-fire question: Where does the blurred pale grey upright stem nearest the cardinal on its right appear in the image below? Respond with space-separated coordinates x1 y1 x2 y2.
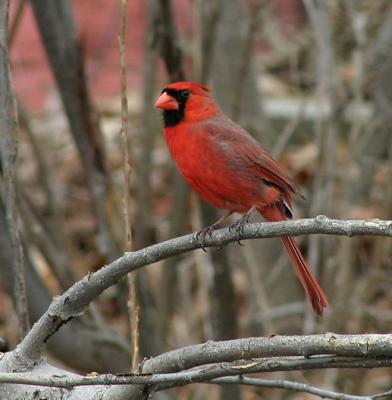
303 0 340 333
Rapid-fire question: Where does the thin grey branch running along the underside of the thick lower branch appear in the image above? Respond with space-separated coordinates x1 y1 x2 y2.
0 356 392 391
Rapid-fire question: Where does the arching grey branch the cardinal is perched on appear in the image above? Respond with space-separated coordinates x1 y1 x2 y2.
11 216 392 360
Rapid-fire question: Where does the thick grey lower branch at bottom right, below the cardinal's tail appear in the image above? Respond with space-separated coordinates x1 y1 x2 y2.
143 333 392 373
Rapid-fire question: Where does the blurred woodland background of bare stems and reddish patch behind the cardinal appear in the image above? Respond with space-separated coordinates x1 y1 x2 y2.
0 0 392 399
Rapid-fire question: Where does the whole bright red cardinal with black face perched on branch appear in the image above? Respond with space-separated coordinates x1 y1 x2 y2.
155 82 328 315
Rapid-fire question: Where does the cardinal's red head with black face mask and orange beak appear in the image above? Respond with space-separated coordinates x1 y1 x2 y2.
155 82 219 127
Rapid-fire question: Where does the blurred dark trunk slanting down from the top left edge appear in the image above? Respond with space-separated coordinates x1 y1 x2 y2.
32 0 118 260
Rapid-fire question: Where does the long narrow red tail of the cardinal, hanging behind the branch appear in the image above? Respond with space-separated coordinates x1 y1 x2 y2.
259 207 328 315
